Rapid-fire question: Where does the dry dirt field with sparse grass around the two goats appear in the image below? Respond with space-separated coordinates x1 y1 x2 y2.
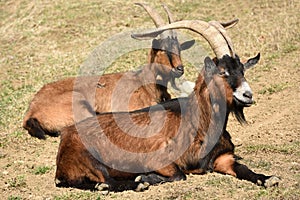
0 0 300 200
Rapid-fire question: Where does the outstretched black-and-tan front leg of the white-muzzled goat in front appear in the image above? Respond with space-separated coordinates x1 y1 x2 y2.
214 153 280 187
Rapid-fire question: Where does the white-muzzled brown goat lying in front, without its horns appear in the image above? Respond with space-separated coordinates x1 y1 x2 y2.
55 55 279 191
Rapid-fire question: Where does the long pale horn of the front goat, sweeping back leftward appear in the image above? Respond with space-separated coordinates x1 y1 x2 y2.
131 20 232 59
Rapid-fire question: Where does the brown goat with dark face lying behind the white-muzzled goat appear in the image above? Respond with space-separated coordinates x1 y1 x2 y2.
23 4 194 139
